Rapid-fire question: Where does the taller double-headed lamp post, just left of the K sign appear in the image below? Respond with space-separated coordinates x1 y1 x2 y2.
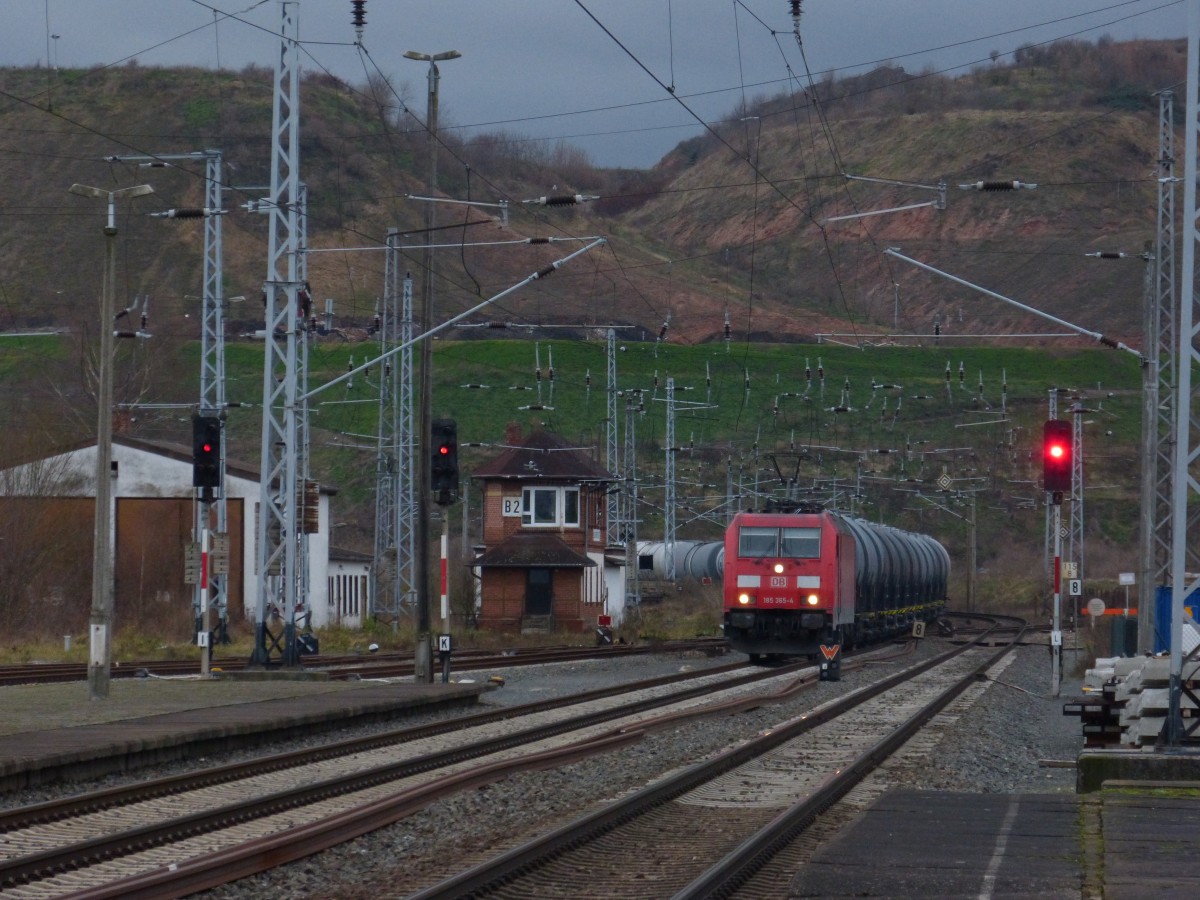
404 50 462 684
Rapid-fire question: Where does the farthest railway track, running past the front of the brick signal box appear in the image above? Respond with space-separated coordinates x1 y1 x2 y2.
0 638 728 686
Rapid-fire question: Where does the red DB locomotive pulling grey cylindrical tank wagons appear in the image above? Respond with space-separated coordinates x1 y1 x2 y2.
724 510 950 662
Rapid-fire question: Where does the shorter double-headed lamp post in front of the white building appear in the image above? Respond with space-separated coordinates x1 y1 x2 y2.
70 185 154 700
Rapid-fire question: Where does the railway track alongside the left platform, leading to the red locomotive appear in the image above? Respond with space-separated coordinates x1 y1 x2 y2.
0 643 854 898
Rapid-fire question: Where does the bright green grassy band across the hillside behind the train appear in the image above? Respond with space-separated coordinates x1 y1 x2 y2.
216 340 1140 600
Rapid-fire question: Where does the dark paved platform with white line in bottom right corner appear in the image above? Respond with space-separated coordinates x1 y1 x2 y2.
788 787 1200 900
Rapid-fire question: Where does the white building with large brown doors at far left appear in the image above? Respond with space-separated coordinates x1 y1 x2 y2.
0 434 340 628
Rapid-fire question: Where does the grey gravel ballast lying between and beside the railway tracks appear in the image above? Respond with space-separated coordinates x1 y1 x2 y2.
182 641 1082 900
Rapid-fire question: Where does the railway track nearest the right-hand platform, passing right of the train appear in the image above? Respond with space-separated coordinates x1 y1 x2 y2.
413 623 1020 900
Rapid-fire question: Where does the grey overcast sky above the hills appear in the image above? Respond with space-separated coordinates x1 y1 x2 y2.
0 0 1188 167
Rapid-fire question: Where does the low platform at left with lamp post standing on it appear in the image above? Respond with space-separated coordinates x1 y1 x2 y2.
0 678 488 791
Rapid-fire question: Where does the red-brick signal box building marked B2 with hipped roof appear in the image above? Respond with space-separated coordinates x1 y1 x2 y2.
472 426 625 632
